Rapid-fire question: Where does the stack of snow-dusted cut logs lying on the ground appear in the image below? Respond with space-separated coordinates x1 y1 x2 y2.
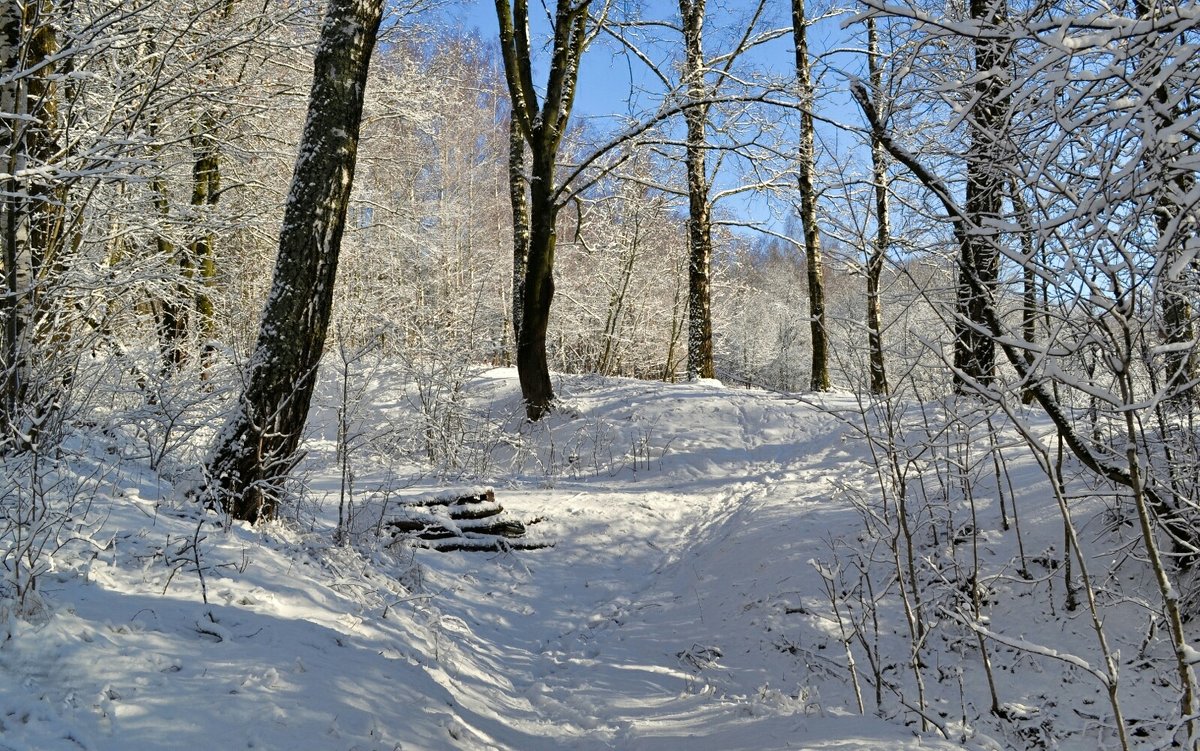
384 489 550 552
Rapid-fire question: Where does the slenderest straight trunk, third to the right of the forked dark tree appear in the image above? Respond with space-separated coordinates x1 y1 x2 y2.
866 18 892 395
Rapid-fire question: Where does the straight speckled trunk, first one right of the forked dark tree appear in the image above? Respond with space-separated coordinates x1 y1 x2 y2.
679 0 716 380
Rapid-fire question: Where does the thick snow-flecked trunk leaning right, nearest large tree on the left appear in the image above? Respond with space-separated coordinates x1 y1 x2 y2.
208 0 384 522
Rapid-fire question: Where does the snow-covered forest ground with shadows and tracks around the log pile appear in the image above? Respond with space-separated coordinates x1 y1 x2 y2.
0 370 1175 751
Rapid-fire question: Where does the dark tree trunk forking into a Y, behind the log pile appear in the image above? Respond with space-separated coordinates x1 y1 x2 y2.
496 0 590 420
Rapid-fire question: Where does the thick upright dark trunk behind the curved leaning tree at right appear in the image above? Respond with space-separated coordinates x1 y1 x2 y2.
954 0 1008 393
